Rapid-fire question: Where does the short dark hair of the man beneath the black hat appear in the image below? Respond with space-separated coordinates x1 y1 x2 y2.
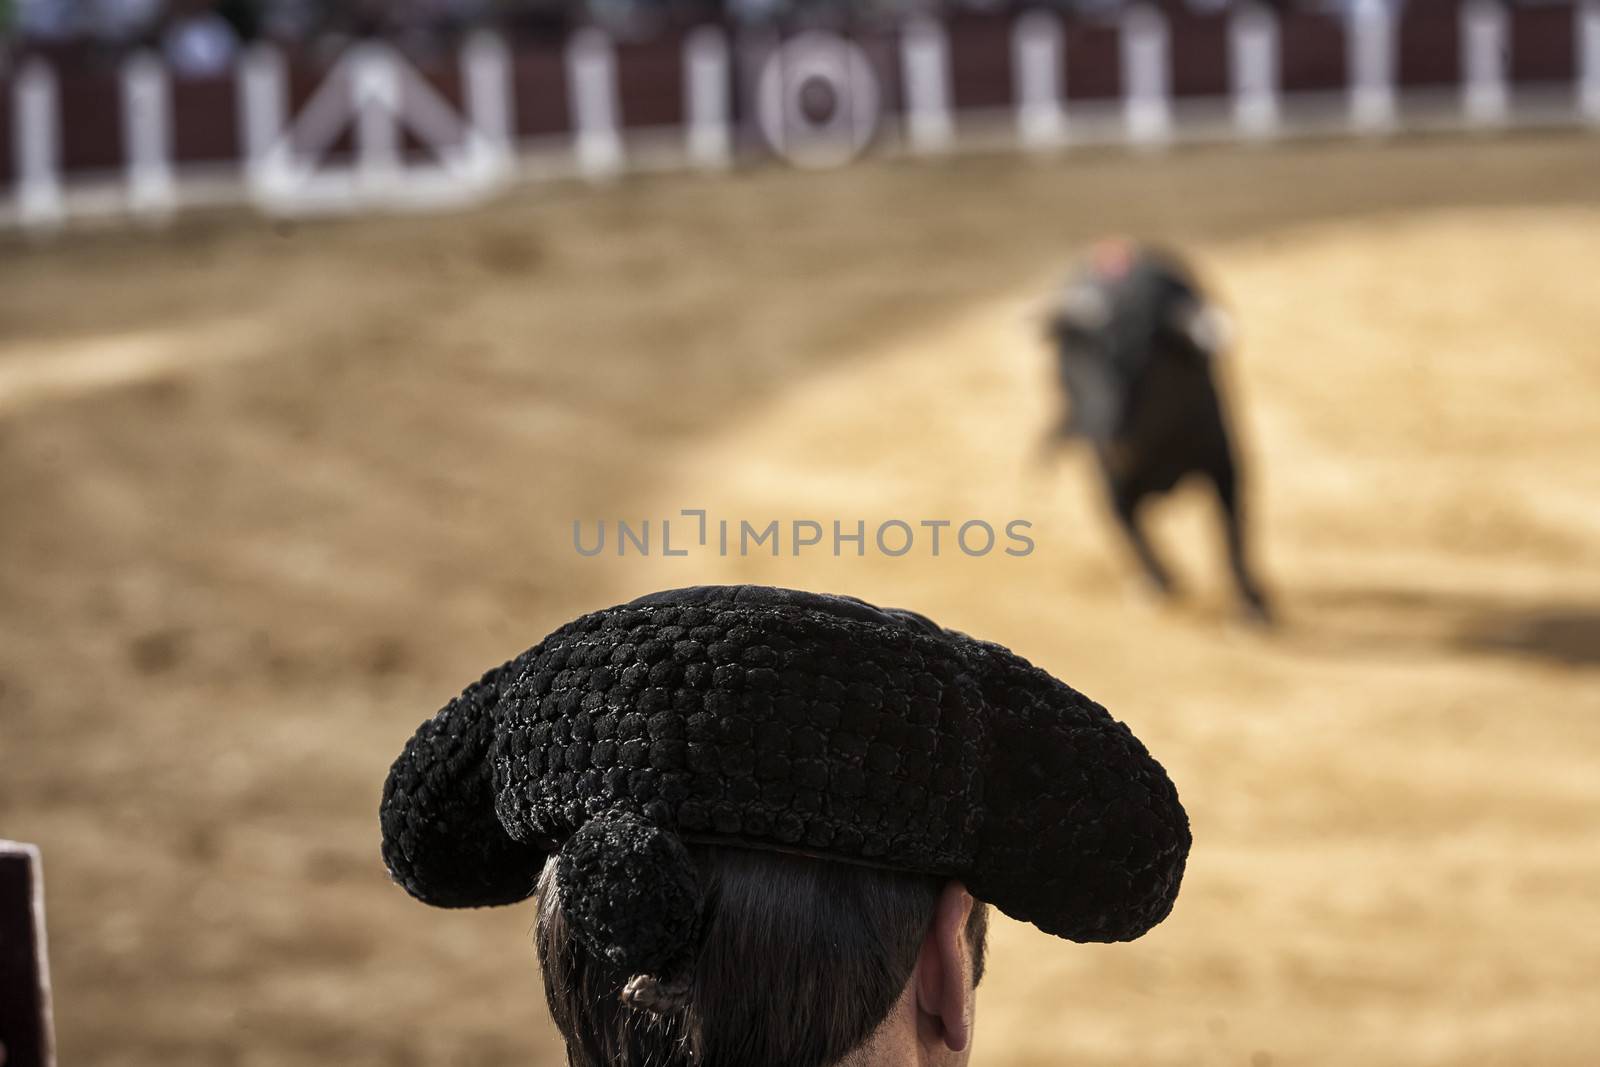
534 845 987 1067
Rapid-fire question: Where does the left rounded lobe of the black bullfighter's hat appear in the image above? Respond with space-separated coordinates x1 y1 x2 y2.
379 653 544 907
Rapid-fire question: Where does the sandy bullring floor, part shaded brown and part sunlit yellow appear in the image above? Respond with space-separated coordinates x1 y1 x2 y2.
0 138 1600 1067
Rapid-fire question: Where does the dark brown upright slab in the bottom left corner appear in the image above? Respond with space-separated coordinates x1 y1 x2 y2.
0 840 56 1067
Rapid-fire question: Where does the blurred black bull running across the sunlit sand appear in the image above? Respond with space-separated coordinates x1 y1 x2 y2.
1046 240 1267 619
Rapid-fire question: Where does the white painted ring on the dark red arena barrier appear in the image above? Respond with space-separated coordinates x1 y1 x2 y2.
755 32 883 168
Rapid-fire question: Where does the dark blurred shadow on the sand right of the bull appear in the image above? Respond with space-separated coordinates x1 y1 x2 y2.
1293 587 1600 667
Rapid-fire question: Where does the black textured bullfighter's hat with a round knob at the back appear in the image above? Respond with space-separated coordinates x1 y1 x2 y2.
381 585 1190 974
